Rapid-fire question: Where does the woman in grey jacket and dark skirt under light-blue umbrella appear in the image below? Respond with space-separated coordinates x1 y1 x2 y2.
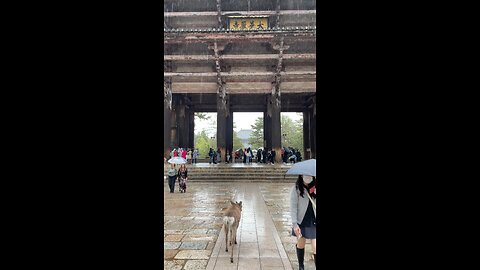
287 159 317 270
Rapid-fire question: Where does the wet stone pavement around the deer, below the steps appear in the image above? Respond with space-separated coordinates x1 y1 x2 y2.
164 182 315 270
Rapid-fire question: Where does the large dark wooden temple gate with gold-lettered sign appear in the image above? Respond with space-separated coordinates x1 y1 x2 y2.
164 0 316 162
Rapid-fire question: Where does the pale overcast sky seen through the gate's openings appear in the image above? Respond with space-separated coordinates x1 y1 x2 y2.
195 112 302 135
